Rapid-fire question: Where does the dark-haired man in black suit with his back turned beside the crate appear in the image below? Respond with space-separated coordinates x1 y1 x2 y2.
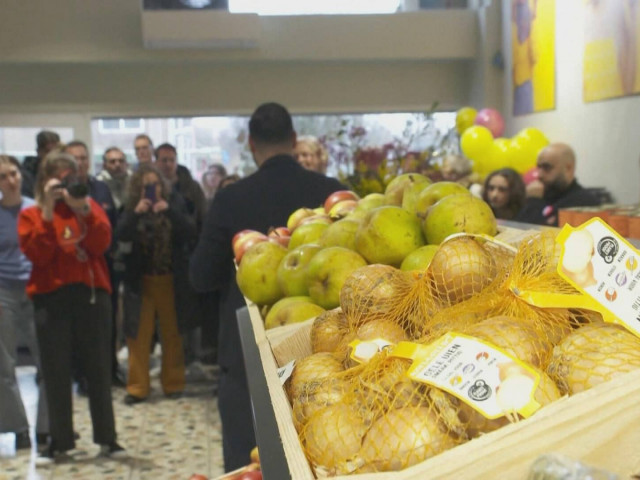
190 103 345 471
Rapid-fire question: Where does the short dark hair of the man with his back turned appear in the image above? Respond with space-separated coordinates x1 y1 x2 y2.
249 103 294 145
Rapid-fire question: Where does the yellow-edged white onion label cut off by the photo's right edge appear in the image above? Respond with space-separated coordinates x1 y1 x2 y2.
556 218 640 336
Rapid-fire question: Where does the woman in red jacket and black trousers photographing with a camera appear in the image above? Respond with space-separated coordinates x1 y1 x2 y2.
18 152 126 465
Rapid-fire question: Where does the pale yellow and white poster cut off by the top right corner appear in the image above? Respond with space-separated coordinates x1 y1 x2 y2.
582 0 640 102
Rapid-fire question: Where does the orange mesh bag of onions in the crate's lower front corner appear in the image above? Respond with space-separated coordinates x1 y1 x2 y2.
300 351 460 476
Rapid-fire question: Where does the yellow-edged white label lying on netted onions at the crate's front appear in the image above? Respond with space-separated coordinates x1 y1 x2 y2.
398 332 540 419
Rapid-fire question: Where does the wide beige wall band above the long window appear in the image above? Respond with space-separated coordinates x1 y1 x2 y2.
0 0 477 116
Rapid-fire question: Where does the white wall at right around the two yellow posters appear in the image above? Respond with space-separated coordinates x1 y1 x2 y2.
503 0 640 203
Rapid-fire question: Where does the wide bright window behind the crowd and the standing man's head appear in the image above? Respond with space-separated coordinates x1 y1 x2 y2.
91 112 455 179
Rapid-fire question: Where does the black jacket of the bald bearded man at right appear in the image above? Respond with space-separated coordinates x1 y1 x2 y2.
514 180 600 226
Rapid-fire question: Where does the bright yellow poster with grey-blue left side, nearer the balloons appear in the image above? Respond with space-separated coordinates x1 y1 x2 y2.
511 0 556 115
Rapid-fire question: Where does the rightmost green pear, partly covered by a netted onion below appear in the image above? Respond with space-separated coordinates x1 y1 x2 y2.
422 193 498 244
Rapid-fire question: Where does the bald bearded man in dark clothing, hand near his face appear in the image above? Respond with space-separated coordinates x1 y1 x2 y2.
514 143 600 226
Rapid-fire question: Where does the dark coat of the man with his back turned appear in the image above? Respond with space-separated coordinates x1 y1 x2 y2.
189 155 345 368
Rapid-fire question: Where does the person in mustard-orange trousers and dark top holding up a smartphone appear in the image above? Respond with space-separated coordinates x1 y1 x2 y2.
116 164 197 405
